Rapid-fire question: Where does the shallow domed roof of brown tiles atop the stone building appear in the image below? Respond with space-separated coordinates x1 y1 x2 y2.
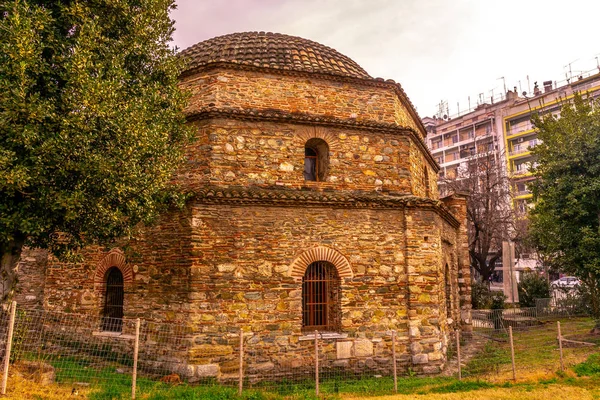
181 32 371 78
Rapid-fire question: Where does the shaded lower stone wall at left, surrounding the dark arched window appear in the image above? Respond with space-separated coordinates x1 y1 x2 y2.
44 210 191 322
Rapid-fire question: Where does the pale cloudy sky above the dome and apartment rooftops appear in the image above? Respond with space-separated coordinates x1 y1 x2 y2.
171 0 600 117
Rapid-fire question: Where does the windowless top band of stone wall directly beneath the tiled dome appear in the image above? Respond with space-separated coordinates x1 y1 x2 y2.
181 69 420 132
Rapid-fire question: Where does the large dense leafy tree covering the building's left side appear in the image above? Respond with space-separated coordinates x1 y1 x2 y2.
0 0 190 300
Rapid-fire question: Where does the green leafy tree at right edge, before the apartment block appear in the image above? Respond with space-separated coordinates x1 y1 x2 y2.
530 95 600 318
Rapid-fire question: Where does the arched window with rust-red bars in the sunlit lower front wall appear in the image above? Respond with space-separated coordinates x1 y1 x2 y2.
302 261 341 331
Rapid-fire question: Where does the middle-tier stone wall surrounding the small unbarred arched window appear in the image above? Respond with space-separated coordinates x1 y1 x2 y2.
180 120 423 193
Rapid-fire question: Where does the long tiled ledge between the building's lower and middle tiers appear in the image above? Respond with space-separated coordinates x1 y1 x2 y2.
192 186 460 228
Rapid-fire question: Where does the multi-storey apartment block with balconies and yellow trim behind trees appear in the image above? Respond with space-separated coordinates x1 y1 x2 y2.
423 68 600 288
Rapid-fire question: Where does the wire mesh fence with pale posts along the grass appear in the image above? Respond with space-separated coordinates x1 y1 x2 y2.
0 300 600 398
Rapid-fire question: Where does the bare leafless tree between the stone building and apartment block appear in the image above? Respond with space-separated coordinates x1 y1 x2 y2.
444 151 515 282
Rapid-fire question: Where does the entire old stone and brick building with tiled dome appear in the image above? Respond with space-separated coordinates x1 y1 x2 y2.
16 32 470 376
